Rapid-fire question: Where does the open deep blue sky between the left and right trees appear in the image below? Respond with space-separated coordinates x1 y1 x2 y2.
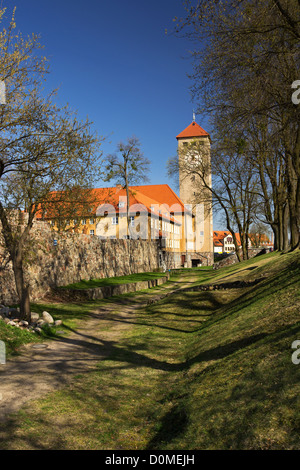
2 0 217 218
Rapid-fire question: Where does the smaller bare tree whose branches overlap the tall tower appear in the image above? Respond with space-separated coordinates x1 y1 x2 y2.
167 140 258 261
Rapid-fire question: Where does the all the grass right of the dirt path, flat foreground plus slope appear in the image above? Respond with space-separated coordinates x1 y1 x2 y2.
0 252 300 450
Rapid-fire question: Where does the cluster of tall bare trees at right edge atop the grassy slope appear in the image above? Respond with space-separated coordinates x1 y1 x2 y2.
176 0 300 249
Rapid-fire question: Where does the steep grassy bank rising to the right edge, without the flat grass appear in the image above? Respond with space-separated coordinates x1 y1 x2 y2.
152 253 300 449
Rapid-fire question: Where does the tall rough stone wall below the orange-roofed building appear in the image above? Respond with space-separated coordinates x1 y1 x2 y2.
0 222 159 305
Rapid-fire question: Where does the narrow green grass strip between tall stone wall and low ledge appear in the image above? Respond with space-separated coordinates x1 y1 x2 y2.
60 272 172 289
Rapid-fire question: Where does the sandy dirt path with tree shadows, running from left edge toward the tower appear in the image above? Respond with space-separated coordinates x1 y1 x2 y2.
0 274 195 421
